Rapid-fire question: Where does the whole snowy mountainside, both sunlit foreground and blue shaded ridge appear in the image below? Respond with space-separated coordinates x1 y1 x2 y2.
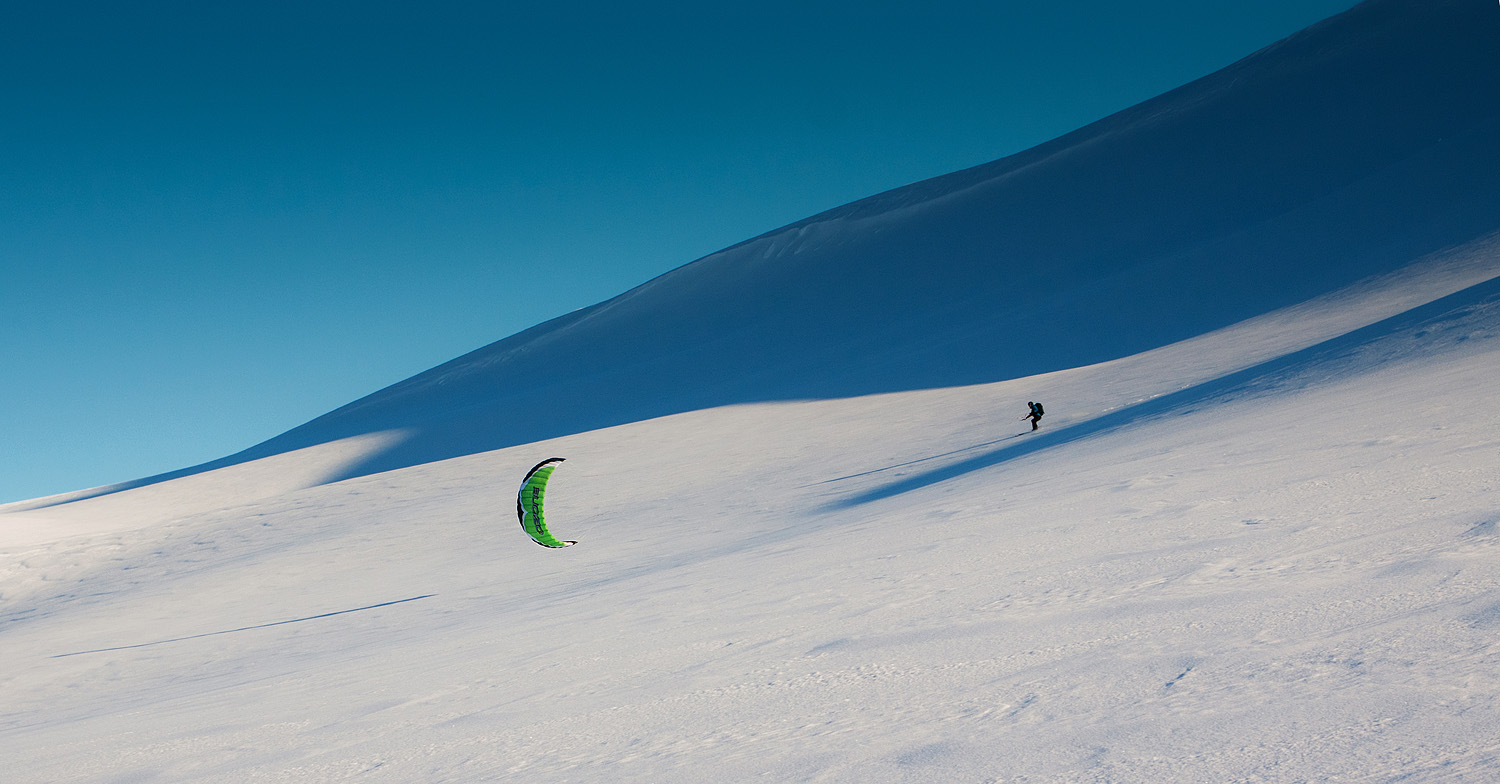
0 0 1500 784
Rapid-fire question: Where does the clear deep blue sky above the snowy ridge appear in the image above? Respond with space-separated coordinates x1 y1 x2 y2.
0 0 1355 502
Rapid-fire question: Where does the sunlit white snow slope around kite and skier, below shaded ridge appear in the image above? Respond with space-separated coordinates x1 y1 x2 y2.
0 236 1500 784
